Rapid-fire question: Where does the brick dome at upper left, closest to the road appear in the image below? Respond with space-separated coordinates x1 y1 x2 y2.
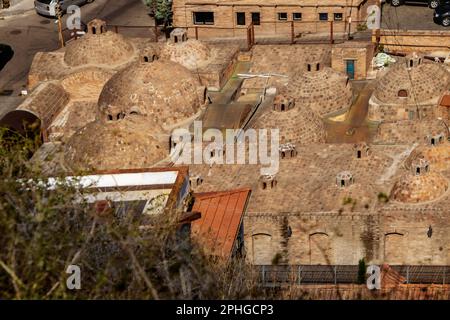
64 31 134 67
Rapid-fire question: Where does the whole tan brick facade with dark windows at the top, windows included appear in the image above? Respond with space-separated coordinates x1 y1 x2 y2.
173 0 377 38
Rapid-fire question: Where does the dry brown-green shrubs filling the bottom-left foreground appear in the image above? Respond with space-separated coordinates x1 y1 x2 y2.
0 130 260 299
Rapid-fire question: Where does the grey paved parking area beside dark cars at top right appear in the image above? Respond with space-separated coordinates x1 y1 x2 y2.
382 4 444 32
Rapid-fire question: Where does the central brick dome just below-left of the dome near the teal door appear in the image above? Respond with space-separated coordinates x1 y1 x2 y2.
253 95 326 145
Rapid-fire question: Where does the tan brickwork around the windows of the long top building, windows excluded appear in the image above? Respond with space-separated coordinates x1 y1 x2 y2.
173 0 366 38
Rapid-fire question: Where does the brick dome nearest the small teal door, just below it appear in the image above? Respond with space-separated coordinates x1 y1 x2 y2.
283 67 353 116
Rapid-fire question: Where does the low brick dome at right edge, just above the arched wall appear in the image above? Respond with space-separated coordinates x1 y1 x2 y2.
391 172 448 203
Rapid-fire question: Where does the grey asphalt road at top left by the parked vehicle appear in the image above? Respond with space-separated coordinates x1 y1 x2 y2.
0 0 154 117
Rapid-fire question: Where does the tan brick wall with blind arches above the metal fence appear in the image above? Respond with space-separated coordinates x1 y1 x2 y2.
244 208 450 265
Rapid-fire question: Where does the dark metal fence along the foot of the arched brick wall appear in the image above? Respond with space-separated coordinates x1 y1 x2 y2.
256 265 450 286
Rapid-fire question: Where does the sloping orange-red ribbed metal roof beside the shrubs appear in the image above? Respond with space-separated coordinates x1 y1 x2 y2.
192 189 251 258
